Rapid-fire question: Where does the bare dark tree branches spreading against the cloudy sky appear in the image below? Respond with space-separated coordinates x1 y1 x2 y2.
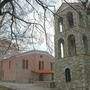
0 0 89 52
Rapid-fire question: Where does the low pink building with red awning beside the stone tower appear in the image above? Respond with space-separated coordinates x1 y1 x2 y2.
0 50 54 82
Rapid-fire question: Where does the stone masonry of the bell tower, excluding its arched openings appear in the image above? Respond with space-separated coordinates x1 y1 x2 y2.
55 3 90 90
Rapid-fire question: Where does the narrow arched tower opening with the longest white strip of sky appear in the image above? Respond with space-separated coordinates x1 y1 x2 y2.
58 39 64 58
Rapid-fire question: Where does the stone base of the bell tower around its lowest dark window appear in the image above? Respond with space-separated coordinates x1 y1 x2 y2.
55 56 90 90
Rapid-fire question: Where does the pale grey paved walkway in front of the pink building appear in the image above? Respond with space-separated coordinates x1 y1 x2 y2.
0 82 54 90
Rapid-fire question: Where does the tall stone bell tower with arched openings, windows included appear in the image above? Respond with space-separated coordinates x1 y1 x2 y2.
54 3 90 90
